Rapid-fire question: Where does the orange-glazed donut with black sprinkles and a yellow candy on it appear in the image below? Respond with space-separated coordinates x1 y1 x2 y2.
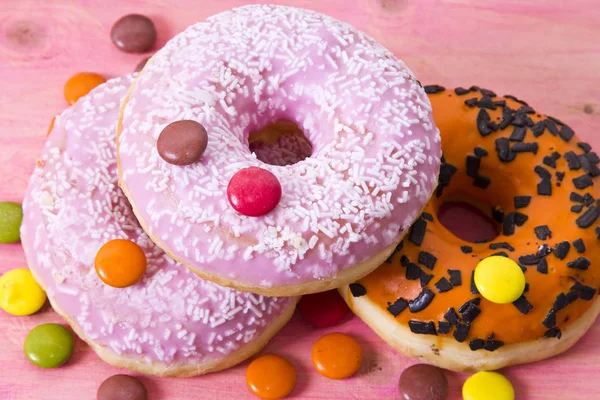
340 86 600 370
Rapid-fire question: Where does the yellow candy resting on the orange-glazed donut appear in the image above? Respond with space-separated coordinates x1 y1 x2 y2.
475 256 525 304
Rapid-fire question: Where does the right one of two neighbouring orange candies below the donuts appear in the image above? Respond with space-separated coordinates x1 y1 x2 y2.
312 333 362 379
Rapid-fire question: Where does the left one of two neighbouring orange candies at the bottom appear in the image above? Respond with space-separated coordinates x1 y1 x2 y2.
246 354 296 399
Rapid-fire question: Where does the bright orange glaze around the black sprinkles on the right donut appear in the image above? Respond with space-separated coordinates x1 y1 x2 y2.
349 86 600 344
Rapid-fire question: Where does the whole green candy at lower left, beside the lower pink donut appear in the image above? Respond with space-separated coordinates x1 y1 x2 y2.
24 324 75 368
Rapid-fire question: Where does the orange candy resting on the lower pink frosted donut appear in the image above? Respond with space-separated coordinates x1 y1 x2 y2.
94 239 146 288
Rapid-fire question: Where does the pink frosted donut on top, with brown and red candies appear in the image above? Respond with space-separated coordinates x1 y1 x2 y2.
117 5 441 295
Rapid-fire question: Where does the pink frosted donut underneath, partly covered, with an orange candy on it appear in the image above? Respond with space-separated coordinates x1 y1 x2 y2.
21 77 296 376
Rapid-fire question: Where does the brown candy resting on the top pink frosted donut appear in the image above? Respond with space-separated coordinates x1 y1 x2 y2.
156 120 208 165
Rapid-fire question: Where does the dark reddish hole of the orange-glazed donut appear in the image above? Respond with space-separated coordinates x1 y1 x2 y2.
437 198 501 243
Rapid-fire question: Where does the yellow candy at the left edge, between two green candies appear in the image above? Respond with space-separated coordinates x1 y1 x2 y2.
0 268 46 315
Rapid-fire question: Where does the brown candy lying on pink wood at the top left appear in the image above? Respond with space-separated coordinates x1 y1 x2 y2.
110 14 156 53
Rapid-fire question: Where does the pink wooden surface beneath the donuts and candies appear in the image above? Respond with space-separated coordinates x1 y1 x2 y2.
0 0 600 400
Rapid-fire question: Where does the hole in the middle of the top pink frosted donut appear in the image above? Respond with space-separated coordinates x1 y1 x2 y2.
248 120 313 166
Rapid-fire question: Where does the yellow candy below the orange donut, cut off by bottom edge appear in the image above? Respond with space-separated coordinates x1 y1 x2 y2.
463 371 515 400
